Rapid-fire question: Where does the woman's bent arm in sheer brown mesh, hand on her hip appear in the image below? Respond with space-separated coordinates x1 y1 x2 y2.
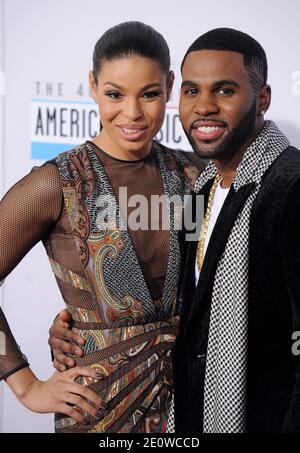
0 164 104 416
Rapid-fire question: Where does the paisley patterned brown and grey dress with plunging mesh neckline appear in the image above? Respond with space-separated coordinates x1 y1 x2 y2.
44 142 199 433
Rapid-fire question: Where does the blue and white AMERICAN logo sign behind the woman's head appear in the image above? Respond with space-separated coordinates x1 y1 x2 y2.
31 98 190 160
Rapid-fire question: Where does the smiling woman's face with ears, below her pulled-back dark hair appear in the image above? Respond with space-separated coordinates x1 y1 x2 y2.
90 55 174 160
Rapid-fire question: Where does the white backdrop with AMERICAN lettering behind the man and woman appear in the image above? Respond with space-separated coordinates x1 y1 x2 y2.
0 0 300 432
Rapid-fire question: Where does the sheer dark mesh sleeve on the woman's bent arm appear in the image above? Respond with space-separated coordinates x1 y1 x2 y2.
0 163 62 380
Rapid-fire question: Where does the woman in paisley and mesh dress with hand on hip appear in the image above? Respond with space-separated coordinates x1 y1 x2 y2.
0 22 203 432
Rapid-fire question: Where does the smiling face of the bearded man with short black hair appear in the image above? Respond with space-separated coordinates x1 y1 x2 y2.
179 50 258 160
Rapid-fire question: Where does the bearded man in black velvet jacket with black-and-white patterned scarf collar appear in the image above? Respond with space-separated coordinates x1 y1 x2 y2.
51 29 300 433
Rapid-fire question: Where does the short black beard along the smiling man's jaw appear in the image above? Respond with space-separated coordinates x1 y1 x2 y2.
184 101 256 160
